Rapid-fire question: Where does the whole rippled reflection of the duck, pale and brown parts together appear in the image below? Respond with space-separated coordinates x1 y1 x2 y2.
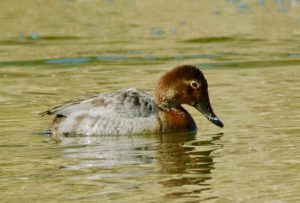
61 133 222 198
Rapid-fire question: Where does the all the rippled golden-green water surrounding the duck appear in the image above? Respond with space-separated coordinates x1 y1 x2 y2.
0 0 300 202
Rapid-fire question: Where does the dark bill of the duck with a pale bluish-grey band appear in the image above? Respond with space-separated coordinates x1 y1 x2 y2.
194 95 224 128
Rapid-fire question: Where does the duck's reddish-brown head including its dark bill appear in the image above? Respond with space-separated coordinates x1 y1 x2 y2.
154 65 223 128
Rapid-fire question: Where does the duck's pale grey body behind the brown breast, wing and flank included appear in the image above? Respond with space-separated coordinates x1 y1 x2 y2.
42 89 161 135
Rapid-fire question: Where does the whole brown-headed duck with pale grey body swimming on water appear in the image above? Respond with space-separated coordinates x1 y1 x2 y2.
40 65 224 136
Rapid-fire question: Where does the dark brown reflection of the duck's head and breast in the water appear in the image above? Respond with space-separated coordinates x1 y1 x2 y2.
157 134 222 197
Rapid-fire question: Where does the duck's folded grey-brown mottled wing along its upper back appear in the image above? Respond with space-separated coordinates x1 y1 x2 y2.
40 89 157 118
